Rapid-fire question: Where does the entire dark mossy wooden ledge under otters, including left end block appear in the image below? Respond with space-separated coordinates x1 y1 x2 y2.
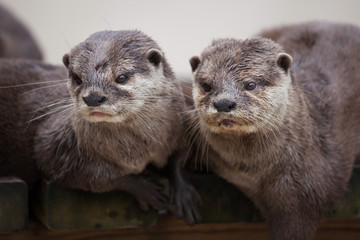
0 168 360 235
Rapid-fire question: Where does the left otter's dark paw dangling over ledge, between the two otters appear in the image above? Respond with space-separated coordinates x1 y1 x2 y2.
171 184 202 226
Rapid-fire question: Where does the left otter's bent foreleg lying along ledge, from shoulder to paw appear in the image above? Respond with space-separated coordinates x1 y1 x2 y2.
34 123 168 210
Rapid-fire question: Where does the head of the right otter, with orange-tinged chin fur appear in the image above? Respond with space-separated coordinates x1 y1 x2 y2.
190 38 292 134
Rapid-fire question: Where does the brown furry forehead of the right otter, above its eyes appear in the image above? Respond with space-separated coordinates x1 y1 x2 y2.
197 38 283 77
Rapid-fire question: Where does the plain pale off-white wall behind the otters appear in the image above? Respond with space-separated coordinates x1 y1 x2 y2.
0 0 360 76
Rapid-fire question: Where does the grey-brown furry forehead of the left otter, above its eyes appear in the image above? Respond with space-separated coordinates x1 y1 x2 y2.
70 31 158 73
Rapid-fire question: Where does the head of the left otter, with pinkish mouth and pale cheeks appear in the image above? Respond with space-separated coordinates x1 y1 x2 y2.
63 31 167 122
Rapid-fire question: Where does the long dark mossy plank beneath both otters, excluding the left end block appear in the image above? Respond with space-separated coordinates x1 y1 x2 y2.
33 168 360 230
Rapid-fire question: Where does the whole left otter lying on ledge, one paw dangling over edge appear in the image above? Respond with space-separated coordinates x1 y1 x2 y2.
0 30 200 225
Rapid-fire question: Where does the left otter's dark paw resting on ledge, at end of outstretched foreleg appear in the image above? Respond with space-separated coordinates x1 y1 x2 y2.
134 179 169 211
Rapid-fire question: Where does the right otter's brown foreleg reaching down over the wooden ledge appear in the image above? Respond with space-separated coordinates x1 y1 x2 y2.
254 186 329 240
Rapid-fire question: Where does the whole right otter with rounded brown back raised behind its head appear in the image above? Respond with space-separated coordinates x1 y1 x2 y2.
190 22 360 240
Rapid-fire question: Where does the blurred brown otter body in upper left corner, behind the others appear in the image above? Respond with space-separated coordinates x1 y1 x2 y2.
0 5 42 60
